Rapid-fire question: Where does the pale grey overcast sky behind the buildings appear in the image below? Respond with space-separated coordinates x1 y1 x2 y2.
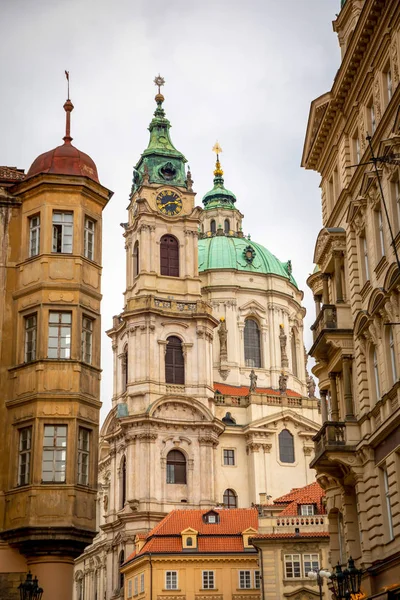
0 0 340 419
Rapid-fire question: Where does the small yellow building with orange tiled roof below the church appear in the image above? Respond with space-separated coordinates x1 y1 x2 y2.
121 508 261 600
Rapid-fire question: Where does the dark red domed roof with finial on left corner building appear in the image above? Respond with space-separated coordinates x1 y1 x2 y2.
26 98 100 183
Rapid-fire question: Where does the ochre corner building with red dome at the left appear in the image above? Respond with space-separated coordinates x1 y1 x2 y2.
0 99 111 600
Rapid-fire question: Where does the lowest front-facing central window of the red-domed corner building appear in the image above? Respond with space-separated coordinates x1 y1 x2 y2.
42 425 67 483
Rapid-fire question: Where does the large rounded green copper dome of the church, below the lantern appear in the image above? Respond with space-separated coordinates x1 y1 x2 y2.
199 235 297 287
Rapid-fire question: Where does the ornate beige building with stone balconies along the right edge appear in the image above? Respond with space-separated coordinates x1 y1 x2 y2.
302 0 400 598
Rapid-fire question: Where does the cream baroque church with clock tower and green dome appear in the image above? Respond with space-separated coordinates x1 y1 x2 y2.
74 84 321 600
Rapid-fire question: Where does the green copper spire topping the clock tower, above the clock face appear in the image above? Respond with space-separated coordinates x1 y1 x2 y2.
132 75 187 192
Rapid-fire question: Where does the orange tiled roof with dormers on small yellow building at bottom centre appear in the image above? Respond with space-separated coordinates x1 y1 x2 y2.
126 508 258 562
